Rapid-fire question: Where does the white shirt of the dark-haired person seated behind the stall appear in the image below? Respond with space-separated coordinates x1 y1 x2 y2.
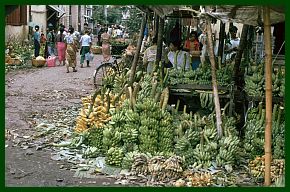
167 50 190 70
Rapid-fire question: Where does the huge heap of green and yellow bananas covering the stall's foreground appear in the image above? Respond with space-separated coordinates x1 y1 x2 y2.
69 56 285 186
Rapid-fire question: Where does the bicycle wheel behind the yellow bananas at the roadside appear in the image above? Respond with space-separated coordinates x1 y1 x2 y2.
94 63 117 89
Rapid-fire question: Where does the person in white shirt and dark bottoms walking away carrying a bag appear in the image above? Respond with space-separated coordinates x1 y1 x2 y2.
80 30 92 68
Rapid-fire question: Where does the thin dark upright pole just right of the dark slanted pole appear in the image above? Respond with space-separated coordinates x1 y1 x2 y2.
156 17 164 76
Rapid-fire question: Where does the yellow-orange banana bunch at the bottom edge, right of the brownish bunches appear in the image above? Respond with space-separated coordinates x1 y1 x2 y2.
181 171 213 187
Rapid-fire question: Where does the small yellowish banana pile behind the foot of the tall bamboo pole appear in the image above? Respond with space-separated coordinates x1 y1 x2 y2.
249 156 285 182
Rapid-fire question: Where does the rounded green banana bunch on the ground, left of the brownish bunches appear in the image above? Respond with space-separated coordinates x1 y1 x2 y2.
105 147 124 167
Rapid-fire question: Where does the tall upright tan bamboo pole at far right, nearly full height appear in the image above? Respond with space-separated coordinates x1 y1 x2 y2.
263 6 272 186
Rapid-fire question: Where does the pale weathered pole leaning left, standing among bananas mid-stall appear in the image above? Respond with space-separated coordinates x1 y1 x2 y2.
206 15 223 138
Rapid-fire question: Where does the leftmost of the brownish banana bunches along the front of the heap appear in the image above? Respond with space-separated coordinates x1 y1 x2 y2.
131 153 148 175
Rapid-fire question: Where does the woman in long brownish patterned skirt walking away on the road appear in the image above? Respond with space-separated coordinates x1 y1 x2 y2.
64 27 77 73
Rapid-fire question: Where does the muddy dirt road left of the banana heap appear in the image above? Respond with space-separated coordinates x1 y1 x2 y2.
5 55 120 186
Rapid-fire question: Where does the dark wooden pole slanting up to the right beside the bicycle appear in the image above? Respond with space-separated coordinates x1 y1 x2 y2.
129 13 147 86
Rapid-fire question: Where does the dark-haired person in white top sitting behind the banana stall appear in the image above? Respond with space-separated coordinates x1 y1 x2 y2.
167 41 191 70
